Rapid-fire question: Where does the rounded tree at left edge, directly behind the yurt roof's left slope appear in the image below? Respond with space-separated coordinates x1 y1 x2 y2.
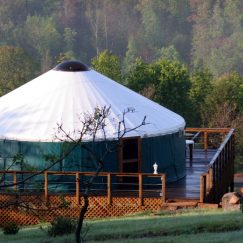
0 46 37 96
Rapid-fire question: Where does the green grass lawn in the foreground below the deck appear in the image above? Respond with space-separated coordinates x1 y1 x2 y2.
0 209 243 243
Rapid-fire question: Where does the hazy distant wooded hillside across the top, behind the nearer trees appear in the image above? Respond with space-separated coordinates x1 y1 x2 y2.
0 0 243 76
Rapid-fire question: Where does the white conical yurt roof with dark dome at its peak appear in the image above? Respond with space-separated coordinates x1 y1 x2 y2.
0 61 185 142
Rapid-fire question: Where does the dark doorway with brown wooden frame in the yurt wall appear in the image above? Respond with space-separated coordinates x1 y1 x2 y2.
119 137 141 181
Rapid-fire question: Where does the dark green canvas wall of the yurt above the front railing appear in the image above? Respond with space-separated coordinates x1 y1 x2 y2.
0 133 186 181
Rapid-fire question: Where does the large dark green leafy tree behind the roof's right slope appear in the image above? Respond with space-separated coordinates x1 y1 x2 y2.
125 58 193 124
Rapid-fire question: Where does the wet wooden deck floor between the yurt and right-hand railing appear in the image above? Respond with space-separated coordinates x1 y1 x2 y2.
166 149 217 201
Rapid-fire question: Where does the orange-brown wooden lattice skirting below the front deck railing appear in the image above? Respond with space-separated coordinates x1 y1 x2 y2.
0 194 163 225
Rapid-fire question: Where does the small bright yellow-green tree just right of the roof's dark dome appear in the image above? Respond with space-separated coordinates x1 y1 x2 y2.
91 50 121 81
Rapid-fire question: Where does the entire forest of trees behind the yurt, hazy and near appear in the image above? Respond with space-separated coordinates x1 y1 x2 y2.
0 0 243 163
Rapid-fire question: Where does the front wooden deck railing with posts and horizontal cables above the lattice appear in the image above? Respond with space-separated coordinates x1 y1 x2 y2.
0 171 165 206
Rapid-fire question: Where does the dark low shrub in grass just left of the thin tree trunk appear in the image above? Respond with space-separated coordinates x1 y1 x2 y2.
47 217 77 237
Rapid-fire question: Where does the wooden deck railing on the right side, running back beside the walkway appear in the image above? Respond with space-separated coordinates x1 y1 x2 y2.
196 129 234 203
